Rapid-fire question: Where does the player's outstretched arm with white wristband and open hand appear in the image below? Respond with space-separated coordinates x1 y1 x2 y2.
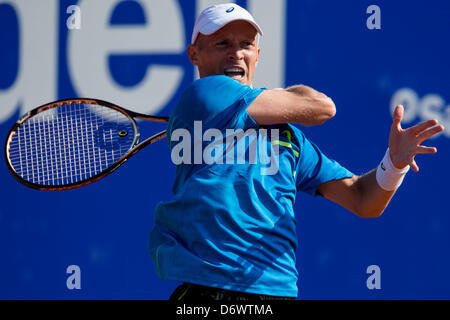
318 105 444 217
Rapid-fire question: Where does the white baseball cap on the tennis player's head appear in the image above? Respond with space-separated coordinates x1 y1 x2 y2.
192 3 263 44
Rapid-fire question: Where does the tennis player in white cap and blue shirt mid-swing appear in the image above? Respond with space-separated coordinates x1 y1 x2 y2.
149 3 443 301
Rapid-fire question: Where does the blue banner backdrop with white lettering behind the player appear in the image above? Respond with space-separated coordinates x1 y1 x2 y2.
0 0 450 299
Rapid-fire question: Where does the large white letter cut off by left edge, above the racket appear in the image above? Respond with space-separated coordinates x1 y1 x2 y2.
0 0 58 122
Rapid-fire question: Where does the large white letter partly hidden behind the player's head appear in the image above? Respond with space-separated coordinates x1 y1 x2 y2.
195 0 287 88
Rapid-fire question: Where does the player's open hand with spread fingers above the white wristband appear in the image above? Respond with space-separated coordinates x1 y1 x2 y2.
389 105 444 172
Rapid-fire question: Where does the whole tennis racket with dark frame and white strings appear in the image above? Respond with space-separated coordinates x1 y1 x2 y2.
5 98 169 191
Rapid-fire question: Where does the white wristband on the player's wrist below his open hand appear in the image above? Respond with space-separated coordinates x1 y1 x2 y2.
376 148 409 191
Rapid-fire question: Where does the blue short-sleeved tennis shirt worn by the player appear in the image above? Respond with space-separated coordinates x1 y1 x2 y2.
149 76 353 297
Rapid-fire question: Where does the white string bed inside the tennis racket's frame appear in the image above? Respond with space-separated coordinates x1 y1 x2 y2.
9 104 135 186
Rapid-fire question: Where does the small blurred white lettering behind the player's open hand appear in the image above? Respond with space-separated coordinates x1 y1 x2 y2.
390 88 450 138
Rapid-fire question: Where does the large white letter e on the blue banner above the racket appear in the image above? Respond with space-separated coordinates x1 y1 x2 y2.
67 0 186 114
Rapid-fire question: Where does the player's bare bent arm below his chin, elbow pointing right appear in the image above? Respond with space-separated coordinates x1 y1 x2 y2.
247 85 336 126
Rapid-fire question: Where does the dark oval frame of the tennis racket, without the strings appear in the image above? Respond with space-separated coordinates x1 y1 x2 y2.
4 98 169 191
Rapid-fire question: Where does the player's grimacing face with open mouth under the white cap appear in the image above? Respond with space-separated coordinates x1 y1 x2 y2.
188 21 260 86
